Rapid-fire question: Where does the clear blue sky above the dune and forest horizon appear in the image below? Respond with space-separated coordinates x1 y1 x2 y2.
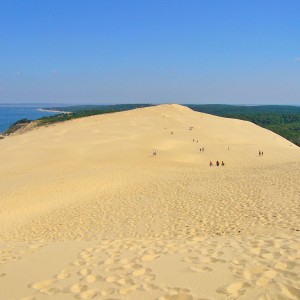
0 0 300 105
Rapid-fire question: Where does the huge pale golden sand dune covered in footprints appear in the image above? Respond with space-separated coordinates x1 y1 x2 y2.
0 105 300 300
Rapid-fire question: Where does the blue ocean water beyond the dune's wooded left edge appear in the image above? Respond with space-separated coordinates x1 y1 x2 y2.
0 104 63 133
